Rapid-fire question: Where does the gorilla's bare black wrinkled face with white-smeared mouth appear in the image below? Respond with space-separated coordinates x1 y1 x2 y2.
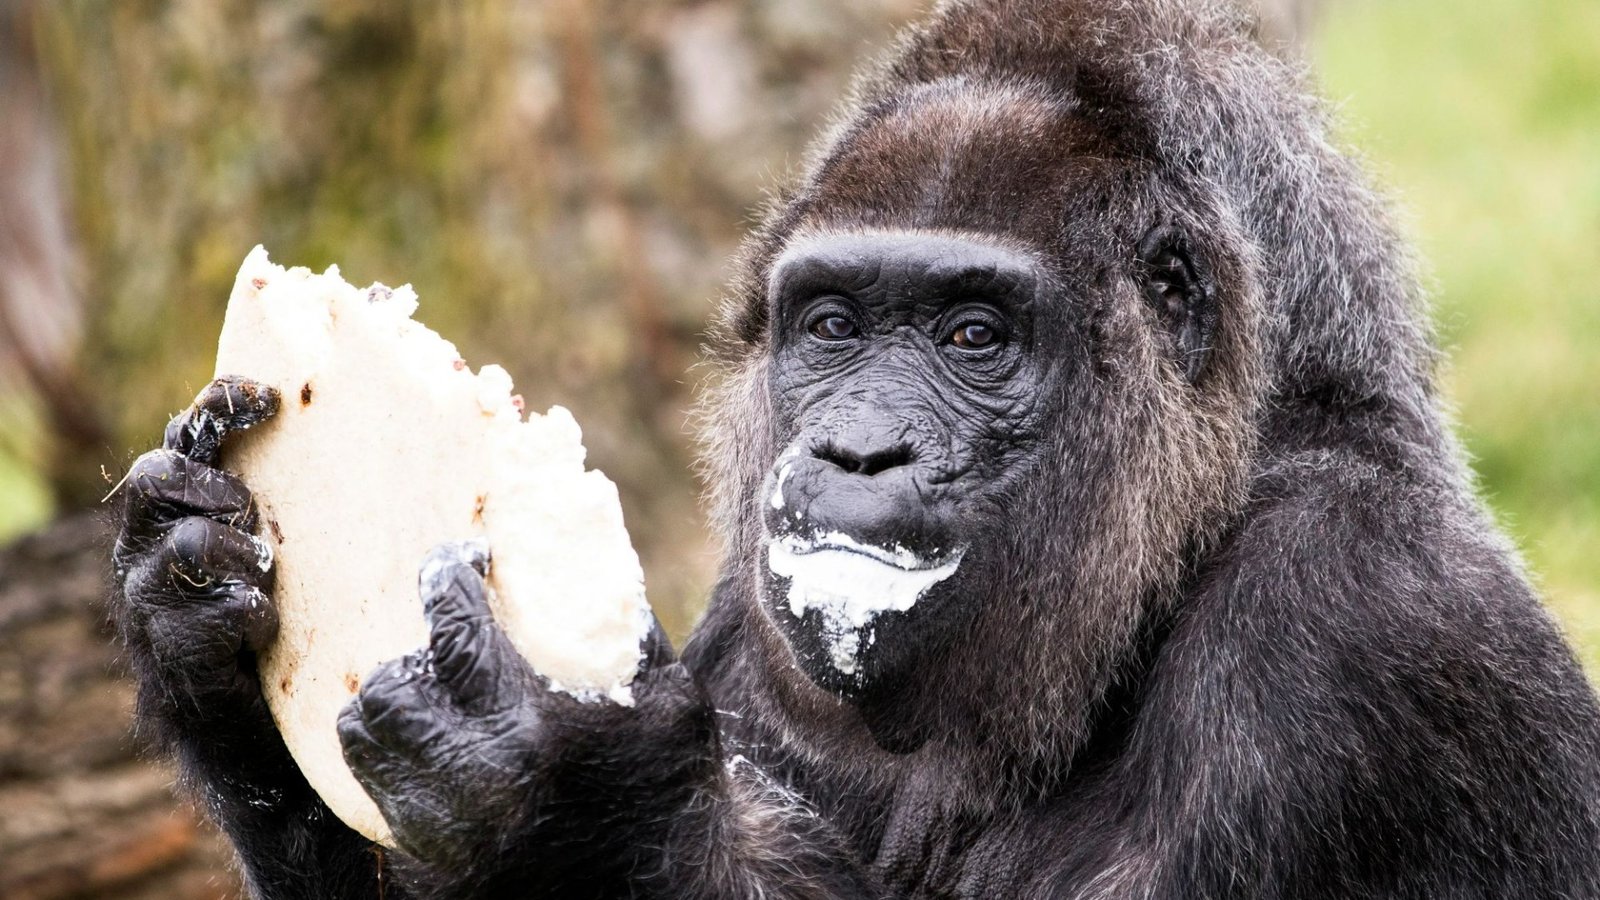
762 229 1053 695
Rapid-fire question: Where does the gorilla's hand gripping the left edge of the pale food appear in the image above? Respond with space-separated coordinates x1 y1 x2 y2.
112 371 278 743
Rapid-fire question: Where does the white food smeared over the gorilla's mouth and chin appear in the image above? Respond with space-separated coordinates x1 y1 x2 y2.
766 532 966 674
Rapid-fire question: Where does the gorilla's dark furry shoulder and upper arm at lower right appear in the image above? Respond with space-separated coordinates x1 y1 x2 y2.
1018 450 1600 900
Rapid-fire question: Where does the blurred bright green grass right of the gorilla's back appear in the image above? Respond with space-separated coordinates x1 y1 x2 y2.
1312 0 1600 673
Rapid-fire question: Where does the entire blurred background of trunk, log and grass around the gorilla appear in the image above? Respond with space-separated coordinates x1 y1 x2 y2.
0 0 1600 900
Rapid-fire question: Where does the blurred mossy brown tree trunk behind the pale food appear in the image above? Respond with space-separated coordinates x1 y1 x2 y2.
0 0 912 634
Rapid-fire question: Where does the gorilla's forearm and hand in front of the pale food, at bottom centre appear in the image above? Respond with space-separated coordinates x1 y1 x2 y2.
339 544 878 898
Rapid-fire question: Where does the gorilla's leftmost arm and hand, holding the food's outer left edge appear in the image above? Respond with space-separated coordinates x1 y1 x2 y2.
114 380 396 898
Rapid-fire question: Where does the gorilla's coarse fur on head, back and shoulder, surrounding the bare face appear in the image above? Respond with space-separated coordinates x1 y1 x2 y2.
686 0 1600 897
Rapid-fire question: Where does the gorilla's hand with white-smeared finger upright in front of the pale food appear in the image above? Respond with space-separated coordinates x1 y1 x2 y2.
339 541 717 889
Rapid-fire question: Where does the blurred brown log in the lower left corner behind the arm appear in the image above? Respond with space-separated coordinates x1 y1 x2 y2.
0 514 242 900
